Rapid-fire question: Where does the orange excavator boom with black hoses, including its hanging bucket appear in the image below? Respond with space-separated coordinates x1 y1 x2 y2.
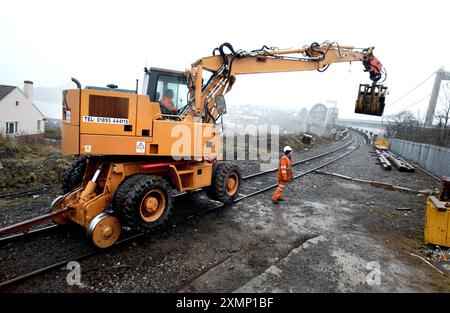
182 42 387 122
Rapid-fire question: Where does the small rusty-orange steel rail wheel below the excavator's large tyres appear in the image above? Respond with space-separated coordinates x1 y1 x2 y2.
87 212 121 248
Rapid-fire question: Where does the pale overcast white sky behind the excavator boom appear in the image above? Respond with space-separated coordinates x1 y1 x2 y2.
0 0 450 119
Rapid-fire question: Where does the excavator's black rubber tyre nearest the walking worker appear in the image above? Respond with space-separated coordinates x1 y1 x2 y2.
203 162 242 204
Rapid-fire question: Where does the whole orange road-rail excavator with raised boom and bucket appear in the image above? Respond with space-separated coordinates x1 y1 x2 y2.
22 42 387 248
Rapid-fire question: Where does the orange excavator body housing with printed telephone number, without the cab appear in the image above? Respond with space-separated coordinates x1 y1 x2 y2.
62 89 220 159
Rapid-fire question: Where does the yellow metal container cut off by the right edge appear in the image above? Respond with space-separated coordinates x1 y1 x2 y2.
424 196 450 247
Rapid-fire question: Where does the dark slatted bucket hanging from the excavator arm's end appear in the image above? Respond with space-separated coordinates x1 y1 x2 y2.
355 83 387 116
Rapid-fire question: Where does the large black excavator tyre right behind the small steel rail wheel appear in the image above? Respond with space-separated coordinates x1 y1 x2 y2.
112 174 173 231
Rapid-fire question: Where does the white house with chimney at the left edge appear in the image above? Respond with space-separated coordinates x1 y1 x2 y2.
0 80 45 137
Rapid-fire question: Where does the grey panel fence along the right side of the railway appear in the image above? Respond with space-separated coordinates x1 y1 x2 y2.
389 139 450 177
